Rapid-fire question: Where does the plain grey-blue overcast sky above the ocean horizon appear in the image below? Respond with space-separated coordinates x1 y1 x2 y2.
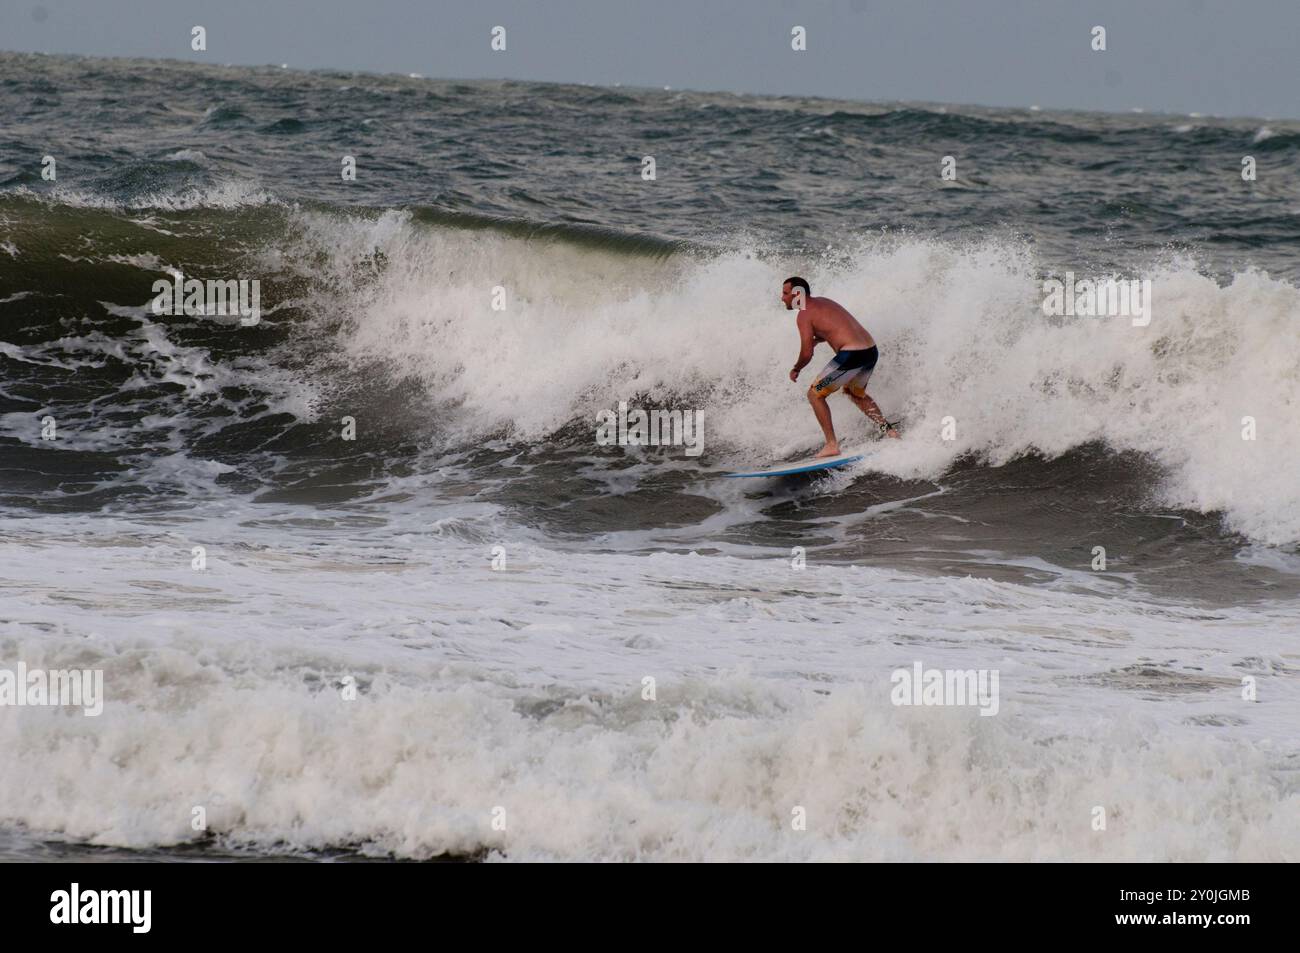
0 0 1300 118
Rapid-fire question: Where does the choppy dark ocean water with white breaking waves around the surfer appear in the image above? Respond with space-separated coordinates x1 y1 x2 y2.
0 53 1300 861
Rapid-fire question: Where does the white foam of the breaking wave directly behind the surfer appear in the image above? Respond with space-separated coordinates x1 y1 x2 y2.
282 213 1300 543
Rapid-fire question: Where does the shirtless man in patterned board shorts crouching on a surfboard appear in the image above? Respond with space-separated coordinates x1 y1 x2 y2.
781 278 898 459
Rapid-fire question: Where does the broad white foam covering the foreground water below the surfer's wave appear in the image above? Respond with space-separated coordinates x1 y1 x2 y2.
0 517 1300 861
